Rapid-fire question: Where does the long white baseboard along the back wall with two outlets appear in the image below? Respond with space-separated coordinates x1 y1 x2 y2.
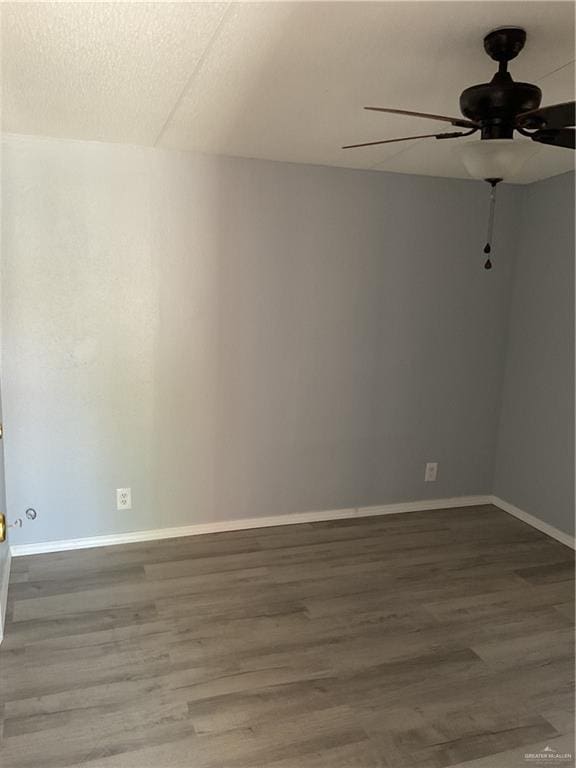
11 496 491 557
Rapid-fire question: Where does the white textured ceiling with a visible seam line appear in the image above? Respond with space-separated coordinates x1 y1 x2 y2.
1 0 574 183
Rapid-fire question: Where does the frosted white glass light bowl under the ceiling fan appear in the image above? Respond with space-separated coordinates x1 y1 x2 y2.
460 139 537 180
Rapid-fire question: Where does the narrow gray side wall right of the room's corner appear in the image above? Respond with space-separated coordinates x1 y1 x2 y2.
494 173 574 533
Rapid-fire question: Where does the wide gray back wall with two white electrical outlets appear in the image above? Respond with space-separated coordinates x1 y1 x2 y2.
3 137 522 543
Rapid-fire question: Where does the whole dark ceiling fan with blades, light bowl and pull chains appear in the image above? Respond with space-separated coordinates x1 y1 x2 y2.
342 27 576 269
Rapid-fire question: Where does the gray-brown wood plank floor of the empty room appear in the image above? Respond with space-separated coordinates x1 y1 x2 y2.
0 507 574 768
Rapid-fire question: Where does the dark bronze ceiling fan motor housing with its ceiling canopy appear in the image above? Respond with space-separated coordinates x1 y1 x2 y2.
460 27 542 139
